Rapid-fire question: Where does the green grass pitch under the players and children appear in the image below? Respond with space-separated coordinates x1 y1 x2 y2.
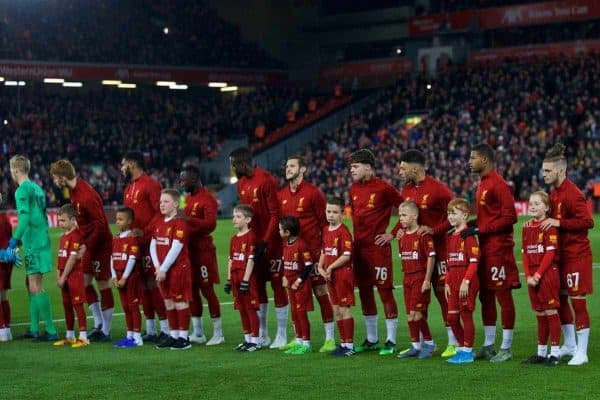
0 216 600 400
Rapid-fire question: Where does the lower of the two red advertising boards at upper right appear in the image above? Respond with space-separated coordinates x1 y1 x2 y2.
471 40 600 64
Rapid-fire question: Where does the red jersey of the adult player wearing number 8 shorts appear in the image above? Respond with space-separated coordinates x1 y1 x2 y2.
183 187 219 252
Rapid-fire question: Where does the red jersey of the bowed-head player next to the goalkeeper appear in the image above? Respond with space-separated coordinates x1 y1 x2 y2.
69 178 112 250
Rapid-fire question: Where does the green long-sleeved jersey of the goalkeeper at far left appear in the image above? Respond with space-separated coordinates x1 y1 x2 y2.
13 180 50 252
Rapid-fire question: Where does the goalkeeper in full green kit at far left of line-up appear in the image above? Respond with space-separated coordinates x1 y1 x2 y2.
4 155 58 341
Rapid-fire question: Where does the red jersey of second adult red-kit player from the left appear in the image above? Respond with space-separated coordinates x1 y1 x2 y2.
123 174 161 242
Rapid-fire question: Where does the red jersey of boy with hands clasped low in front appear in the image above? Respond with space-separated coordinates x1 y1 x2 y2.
152 217 189 271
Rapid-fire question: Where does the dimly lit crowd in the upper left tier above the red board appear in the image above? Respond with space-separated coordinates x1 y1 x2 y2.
0 0 282 68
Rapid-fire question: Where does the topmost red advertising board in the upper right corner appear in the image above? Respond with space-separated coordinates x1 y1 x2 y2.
479 0 600 29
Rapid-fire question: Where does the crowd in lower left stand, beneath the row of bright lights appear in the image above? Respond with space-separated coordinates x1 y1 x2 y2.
0 83 302 205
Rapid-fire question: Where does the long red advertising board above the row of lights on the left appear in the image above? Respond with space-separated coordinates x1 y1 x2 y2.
0 60 288 85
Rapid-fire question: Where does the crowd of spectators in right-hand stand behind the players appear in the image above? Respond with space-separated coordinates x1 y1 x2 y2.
301 54 600 206
